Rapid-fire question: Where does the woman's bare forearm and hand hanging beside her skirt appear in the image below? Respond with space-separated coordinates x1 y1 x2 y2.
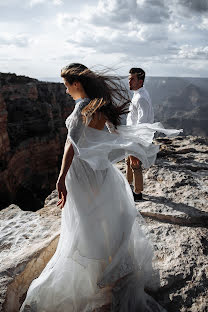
56 141 74 208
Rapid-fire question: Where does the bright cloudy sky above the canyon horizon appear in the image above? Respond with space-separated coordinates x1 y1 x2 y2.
0 0 208 79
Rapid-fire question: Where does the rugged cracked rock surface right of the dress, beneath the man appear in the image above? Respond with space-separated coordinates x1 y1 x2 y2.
118 137 208 312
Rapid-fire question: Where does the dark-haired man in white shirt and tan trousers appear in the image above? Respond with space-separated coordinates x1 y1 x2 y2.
126 68 154 201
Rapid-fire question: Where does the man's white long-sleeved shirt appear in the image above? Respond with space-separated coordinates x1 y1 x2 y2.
126 87 154 126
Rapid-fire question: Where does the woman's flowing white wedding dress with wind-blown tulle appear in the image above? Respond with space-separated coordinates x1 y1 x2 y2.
20 99 182 312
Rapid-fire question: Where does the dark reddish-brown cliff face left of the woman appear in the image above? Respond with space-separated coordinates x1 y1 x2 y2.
0 73 74 210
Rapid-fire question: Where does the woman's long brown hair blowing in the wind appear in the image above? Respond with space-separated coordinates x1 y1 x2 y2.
61 63 130 128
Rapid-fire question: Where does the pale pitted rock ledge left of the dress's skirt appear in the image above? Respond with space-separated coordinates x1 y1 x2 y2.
0 191 61 312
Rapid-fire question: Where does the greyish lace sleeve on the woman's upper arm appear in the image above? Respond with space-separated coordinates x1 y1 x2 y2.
66 99 89 146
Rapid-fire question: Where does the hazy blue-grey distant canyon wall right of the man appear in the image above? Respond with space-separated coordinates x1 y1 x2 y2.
145 77 208 136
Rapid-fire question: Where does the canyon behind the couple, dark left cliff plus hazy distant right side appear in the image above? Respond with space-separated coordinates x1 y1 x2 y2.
0 73 208 211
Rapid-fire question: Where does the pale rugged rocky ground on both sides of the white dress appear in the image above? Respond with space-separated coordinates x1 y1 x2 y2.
0 137 208 312
